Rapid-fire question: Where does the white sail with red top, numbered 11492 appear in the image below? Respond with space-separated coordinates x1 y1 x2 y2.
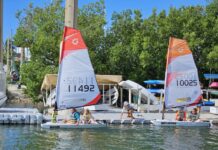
56 27 101 110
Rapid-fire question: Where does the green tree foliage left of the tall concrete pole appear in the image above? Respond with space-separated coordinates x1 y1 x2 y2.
14 0 64 101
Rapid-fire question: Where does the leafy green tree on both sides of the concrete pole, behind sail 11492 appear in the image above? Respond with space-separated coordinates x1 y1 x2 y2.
14 0 106 101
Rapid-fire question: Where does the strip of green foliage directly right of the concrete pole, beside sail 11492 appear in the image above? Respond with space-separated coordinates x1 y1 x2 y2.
78 0 107 73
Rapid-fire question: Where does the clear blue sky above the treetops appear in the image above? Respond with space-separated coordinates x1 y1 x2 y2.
3 0 207 40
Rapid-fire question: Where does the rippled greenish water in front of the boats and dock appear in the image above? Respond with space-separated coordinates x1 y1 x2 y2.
0 125 218 150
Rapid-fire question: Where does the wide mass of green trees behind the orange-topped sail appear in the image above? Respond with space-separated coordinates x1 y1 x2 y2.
104 0 218 82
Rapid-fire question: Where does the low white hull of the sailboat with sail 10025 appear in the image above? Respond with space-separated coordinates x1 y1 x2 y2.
151 120 211 127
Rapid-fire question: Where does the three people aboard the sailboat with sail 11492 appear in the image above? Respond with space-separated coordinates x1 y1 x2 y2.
51 108 96 125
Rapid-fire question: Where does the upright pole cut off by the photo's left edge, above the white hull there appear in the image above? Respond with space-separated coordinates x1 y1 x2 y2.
0 0 3 64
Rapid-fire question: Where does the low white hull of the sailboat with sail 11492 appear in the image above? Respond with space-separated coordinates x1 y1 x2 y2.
41 122 107 129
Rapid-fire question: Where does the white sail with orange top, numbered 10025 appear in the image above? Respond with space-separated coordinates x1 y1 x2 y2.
165 38 202 108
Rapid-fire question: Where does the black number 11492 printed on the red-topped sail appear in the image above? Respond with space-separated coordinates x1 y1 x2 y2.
68 85 95 92
